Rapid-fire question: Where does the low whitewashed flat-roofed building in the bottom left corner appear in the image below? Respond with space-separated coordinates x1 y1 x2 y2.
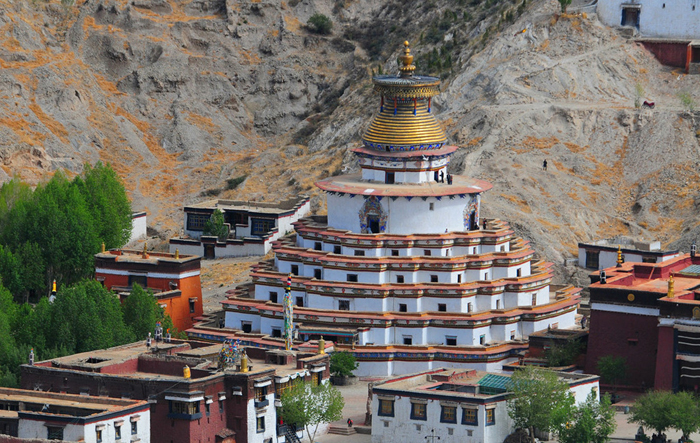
0 388 151 443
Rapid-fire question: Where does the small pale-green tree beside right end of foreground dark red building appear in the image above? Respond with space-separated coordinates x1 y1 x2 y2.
281 383 345 443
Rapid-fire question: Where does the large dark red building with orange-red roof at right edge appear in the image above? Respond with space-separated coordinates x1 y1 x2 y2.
586 253 700 391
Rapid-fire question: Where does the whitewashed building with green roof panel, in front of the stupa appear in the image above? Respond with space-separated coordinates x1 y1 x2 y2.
372 369 599 443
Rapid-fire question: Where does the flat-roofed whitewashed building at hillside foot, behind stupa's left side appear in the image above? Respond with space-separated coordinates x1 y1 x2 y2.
170 195 311 258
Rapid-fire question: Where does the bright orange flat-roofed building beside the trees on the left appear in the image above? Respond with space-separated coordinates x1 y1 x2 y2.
95 249 202 331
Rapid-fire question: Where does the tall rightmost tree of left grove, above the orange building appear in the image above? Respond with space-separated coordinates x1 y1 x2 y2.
73 162 131 249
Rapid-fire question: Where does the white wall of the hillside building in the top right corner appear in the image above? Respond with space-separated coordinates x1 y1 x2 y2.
596 0 700 39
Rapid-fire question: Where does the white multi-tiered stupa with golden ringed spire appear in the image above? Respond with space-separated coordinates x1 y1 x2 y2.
223 43 580 376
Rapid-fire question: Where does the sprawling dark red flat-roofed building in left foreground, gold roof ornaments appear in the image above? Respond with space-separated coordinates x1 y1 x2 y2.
21 341 330 443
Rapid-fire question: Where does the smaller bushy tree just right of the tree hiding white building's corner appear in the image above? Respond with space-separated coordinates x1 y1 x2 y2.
555 392 617 443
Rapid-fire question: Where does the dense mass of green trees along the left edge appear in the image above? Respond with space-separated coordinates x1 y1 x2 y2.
0 163 174 386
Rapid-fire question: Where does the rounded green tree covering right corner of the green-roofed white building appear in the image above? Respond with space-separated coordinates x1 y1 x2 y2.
508 366 574 441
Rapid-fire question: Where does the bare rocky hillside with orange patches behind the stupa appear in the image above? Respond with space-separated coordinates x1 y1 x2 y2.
0 0 700 284
